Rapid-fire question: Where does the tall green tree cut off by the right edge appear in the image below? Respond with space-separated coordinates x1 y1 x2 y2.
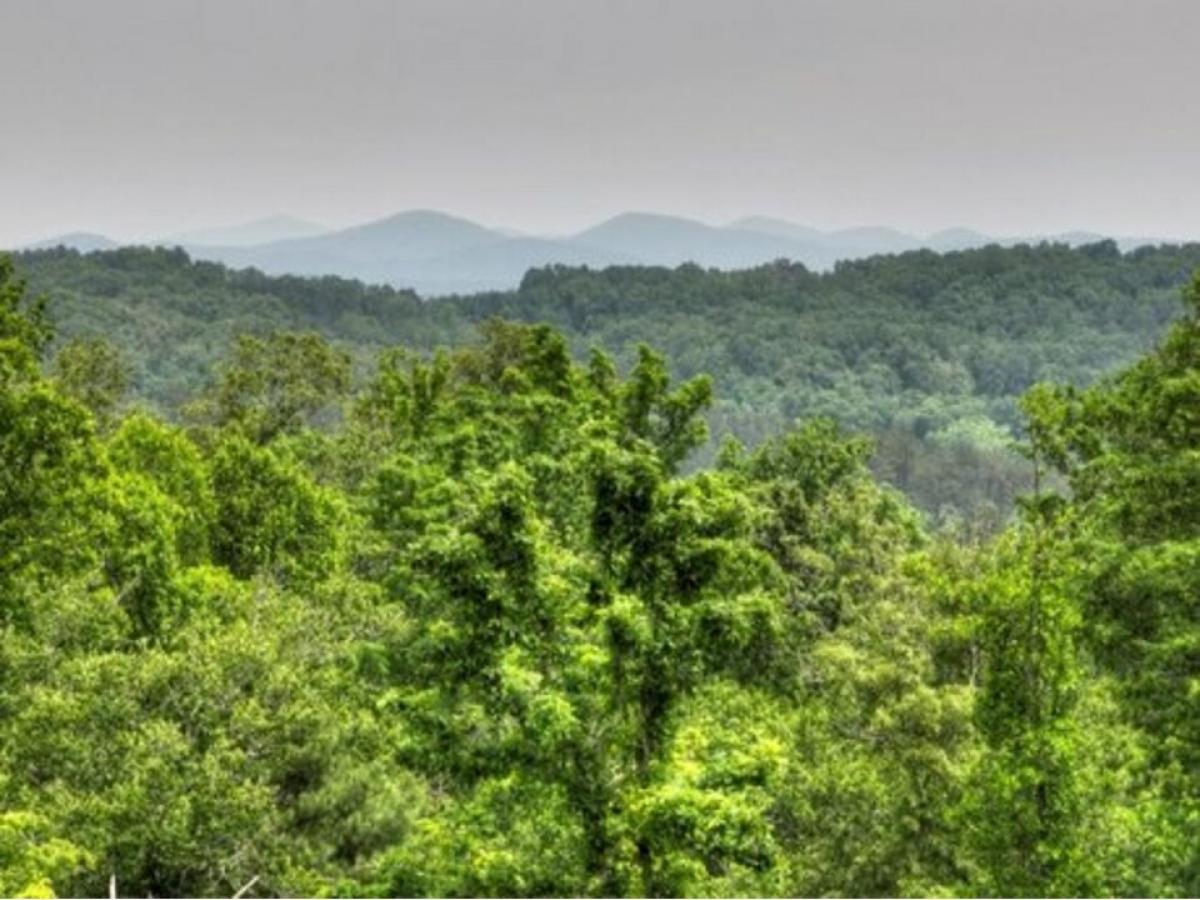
1008 267 1200 893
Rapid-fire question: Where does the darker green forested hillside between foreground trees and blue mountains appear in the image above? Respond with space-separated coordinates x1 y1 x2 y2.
17 242 1200 530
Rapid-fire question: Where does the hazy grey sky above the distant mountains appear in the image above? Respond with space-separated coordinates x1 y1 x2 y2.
0 0 1200 245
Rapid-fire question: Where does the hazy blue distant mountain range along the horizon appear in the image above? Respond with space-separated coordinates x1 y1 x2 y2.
11 210 1159 296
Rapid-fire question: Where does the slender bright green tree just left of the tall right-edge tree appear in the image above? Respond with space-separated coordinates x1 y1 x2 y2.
926 498 1098 895
